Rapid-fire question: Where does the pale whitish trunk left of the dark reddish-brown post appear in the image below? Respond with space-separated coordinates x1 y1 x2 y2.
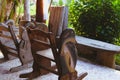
24 0 31 21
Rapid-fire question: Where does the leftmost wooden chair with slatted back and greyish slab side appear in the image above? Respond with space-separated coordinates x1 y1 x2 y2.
0 20 33 72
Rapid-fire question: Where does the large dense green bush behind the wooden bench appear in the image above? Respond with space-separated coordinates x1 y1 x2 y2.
69 0 120 43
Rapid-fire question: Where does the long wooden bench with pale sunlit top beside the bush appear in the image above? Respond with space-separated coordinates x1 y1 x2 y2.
76 36 120 68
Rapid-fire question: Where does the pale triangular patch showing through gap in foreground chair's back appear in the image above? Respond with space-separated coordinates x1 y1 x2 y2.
36 48 54 61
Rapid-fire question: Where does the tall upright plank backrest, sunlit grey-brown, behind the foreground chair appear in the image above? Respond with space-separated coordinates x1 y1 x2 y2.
48 6 68 36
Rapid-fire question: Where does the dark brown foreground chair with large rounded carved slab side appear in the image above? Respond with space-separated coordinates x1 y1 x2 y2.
25 29 87 80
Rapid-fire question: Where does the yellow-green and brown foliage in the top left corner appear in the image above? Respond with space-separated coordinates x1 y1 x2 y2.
0 0 22 22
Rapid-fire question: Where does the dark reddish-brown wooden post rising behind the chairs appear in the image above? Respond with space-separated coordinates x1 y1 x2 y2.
36 0 44 22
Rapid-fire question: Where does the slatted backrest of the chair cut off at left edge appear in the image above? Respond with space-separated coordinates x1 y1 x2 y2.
0 21 19 57
